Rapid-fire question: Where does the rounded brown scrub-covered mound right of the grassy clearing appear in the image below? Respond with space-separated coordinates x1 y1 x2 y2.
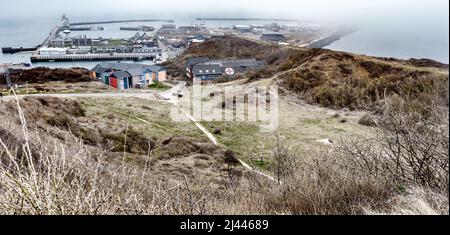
280 50 448 109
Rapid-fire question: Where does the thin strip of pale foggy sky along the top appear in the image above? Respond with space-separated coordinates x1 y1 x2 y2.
0 0 449 25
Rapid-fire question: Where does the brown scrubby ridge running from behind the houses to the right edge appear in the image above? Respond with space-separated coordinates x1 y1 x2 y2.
166 37 448 109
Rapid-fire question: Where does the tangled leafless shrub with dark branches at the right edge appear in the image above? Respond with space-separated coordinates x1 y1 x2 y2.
340 99 449 193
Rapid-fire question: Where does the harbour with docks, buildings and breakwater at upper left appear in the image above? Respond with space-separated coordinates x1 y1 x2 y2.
2 15 174 63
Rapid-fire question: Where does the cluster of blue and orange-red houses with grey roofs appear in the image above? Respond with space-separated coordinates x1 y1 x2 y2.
90 63 167 90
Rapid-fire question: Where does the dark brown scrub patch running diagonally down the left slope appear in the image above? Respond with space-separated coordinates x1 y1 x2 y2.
1 97 243 192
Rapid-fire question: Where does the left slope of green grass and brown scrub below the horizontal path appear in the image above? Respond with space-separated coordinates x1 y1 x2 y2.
0 97 246 187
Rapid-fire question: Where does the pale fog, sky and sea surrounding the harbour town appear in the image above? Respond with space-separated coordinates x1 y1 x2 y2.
0 0 449 63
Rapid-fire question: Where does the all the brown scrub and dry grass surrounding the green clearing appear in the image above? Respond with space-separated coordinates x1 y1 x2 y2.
0 38 449 214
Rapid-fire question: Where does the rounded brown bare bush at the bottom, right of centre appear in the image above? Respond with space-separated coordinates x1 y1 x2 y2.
262 156 391 215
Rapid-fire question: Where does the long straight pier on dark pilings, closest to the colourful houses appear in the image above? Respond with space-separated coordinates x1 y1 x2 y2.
31 53 158 62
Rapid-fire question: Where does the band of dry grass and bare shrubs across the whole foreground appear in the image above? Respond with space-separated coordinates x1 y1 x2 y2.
0 97 448 215
